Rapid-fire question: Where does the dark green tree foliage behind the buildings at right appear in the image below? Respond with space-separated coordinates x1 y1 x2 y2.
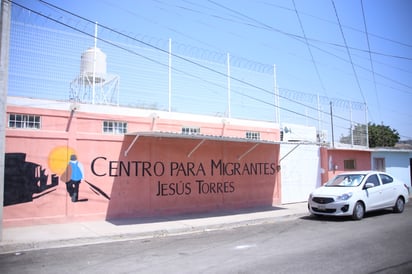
368 123 400 147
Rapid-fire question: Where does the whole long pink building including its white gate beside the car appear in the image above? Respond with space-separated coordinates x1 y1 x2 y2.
3 97 378 227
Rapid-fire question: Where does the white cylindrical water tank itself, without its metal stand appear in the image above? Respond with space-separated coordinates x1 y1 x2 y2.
80 48 106 84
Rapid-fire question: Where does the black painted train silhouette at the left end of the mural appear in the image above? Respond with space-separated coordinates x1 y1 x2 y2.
4 153 59 206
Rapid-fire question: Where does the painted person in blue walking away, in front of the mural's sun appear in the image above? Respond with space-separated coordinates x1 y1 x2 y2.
61 154 84 203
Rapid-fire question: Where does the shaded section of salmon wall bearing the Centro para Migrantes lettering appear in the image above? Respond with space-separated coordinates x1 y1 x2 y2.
104 137 280 219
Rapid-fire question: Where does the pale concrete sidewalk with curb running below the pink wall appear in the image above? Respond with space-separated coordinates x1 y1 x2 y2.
0 202 309 254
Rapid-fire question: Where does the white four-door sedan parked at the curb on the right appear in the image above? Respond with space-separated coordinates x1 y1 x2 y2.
308 171 409 220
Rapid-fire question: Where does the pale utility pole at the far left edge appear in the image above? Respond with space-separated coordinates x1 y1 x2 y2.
0 0 11 241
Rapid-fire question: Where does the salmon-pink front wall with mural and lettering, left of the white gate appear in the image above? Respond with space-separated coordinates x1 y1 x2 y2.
3 101 280 227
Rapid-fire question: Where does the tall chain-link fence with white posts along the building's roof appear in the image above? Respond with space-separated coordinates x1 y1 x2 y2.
8 5 367 146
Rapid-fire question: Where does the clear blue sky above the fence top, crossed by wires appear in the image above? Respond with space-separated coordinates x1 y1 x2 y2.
14 0 412 139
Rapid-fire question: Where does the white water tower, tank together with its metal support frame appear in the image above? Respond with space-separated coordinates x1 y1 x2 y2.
70 47 119 105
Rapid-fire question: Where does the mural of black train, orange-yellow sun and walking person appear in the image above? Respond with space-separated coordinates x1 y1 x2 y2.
4 147 110 206
